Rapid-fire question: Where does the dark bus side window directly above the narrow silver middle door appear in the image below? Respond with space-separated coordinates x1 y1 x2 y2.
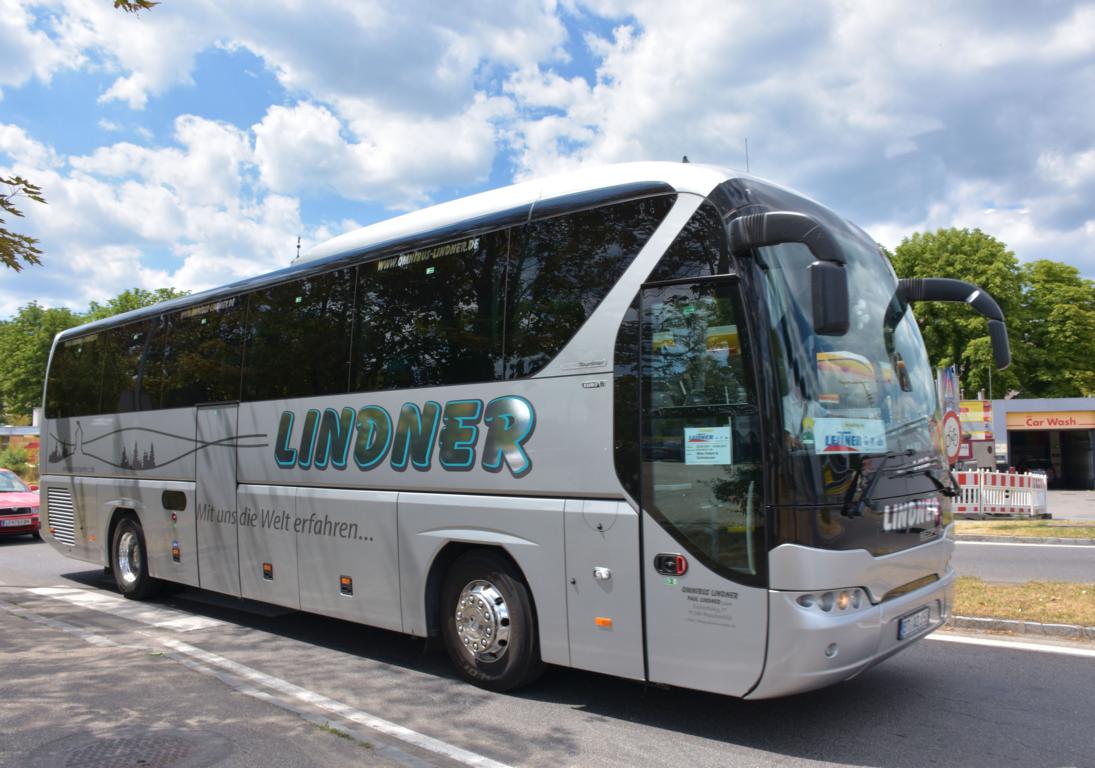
152 297 243 408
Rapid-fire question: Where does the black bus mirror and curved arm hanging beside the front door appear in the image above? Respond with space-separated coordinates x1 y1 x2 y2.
729 210 851 336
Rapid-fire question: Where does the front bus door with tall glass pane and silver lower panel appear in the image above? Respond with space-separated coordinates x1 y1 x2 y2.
639 277 768 696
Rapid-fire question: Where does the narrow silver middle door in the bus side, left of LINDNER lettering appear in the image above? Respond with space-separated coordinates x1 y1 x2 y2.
195 403 240 597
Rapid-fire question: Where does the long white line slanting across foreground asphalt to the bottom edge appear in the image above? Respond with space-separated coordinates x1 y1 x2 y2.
159 638 507 768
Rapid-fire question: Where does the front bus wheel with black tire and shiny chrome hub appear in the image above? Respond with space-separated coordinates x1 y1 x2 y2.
441 550 543 691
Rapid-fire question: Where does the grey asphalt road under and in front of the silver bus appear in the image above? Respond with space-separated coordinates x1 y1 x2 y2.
0 541 1095 768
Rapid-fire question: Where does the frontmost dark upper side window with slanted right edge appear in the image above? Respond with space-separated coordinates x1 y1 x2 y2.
506 195 676 379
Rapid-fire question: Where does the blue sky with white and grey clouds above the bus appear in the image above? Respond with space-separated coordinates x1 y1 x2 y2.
0 0 1095 318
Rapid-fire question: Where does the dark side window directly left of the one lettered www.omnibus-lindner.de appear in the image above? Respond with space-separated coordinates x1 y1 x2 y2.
242 267 356 400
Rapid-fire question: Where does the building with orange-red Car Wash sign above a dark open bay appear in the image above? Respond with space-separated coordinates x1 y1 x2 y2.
992 398 1095 490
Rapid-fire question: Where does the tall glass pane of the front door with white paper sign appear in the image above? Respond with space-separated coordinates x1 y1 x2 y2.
641 280 764 582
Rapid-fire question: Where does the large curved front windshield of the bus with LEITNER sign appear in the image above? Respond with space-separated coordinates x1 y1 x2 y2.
757 230 942 496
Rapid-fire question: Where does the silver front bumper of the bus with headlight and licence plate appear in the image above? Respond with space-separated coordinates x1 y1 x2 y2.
746 566 955 699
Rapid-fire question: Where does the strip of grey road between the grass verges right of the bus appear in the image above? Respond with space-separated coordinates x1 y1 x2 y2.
952 541 1095 584
